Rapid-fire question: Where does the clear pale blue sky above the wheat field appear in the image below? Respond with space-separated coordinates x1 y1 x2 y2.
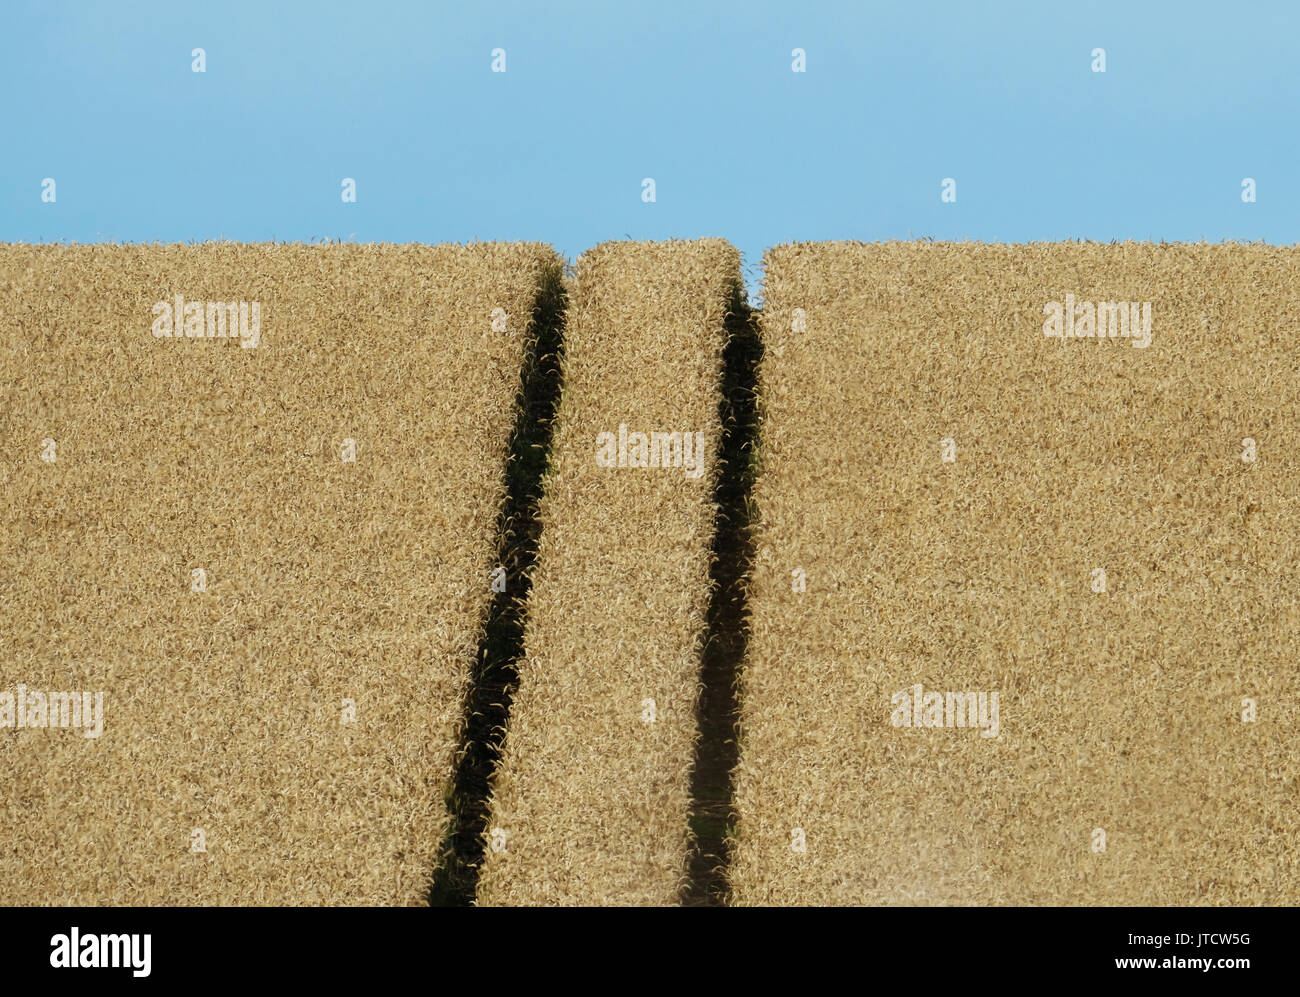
0 0 1300 284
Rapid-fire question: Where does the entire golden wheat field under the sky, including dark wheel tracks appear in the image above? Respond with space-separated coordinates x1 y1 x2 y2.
0 239 1300 906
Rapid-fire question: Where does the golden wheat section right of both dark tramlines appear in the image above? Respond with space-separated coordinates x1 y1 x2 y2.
731 243 1300 905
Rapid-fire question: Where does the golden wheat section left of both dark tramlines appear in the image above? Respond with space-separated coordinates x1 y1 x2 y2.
0 243 562 905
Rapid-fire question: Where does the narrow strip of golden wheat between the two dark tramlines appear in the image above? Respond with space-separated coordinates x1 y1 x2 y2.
478 240 740 905
